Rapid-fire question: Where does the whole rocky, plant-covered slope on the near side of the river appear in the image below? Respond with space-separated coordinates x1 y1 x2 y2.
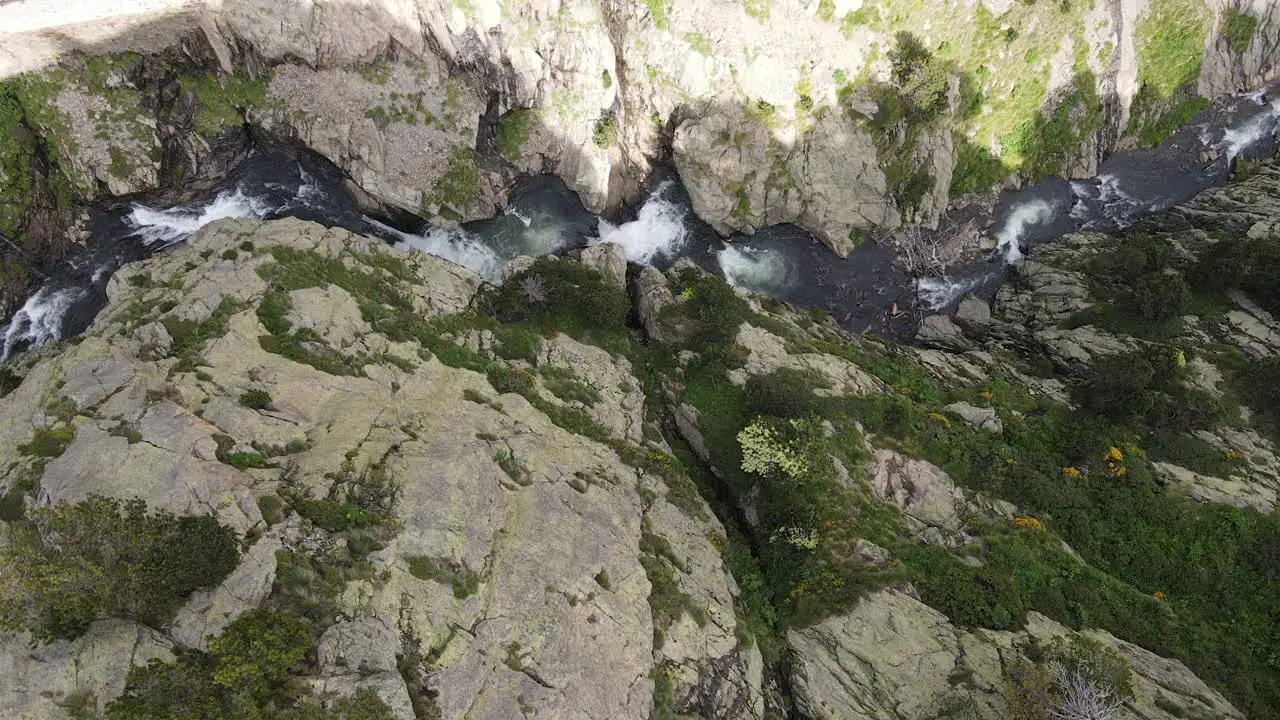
0 159 1280 720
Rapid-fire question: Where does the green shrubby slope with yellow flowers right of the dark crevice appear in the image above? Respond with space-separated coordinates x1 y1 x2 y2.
664 245 1280 714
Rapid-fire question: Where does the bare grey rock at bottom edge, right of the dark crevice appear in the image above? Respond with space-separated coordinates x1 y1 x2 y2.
787 589 1244 720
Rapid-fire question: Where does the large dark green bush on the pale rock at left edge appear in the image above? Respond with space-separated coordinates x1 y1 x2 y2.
0 496 239 642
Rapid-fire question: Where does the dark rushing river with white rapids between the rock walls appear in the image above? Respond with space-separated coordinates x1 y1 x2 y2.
0 86 1280 361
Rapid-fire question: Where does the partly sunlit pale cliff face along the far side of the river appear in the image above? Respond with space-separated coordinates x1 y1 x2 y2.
0 0 1280 267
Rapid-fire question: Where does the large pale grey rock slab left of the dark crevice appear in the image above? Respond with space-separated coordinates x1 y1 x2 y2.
0 215 763 720
